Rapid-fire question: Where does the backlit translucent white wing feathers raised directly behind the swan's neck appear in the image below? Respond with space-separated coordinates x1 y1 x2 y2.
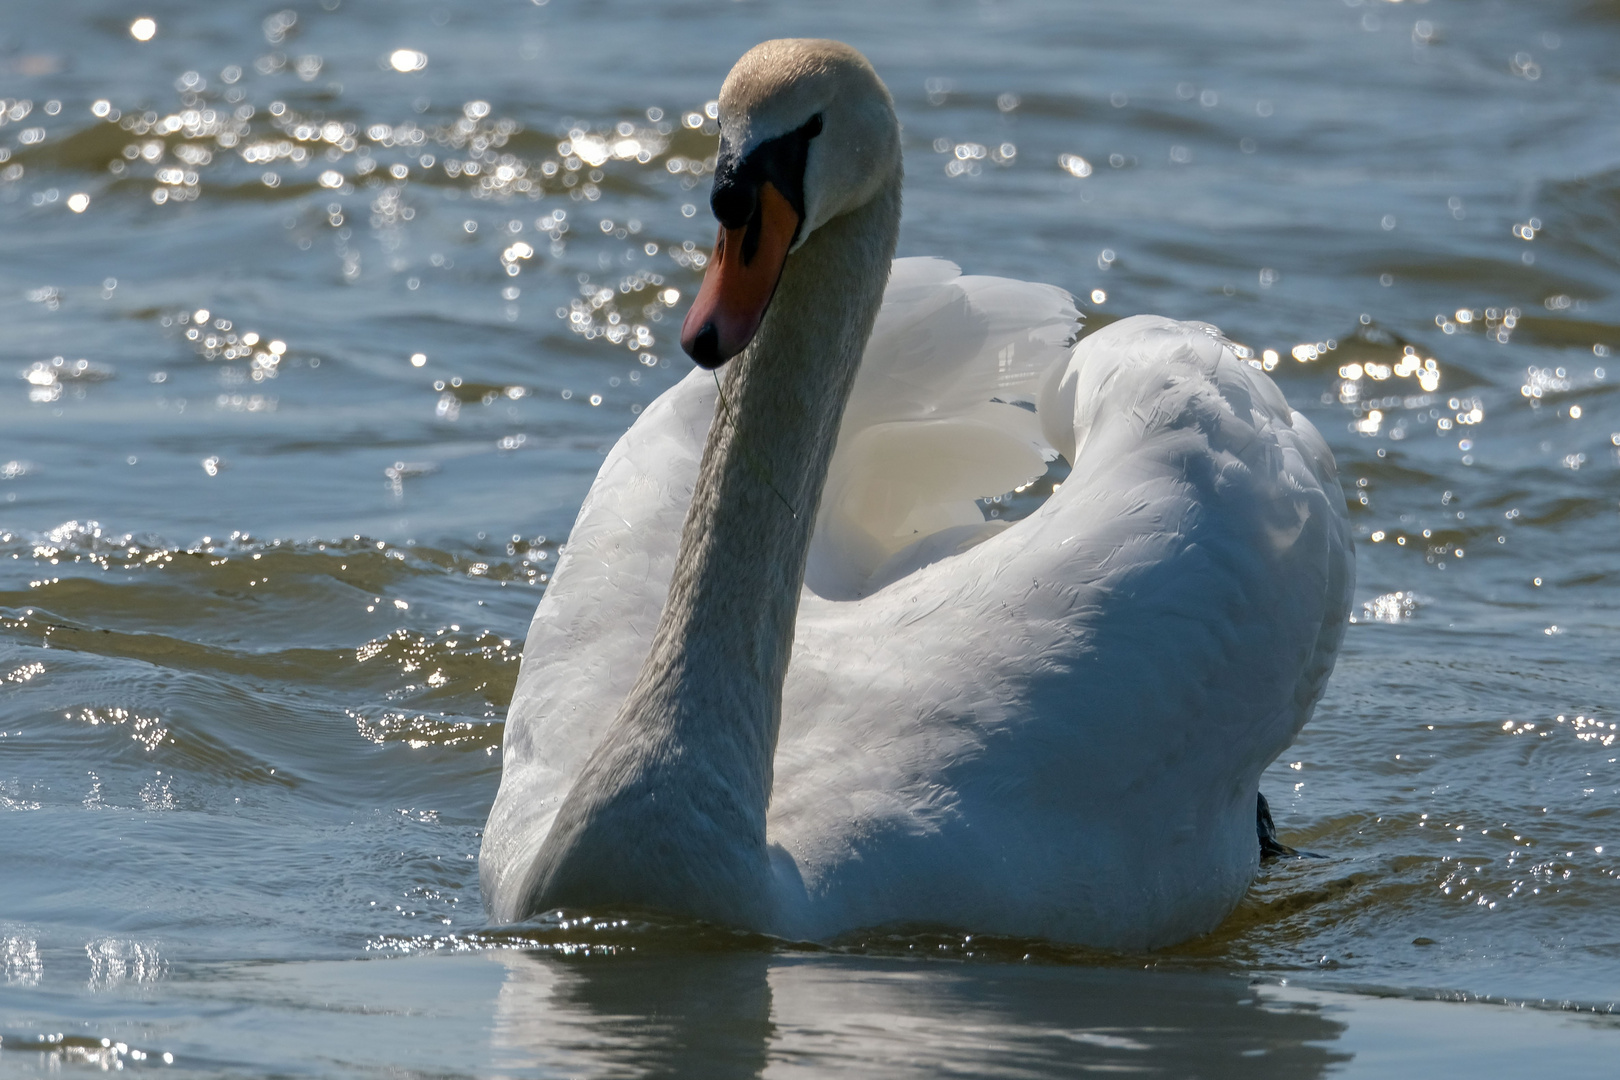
805 259 1079 599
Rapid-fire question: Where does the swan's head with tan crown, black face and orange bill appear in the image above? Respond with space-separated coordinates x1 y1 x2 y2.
680 37 901 368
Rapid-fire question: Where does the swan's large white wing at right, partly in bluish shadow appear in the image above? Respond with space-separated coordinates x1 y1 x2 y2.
771 316 1353 946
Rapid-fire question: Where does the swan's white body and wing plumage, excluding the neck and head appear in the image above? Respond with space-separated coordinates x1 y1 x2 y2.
481 259 1354 946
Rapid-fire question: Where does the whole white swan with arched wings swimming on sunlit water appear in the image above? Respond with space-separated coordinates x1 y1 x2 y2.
480 40 1354 947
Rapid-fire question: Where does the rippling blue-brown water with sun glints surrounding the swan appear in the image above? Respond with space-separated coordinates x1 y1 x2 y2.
0 0 1620 1077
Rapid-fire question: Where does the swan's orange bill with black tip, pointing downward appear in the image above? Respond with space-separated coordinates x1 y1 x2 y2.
680 181 799 368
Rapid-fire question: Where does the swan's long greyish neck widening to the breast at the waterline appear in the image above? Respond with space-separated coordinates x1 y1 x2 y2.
528 176 901 928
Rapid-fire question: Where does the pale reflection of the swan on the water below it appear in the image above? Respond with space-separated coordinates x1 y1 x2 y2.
491 950 1349 1080
